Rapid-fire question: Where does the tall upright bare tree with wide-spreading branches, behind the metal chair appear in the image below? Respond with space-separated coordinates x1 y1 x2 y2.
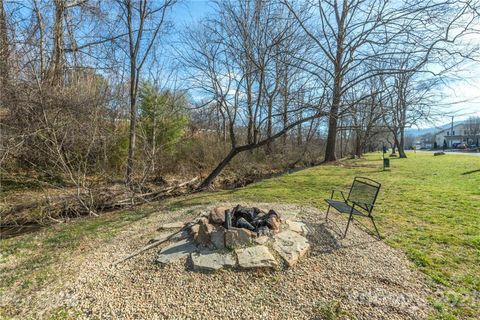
281 0 478 161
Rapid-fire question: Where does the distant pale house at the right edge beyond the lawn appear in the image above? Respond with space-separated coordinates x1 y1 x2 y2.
435 122 480 148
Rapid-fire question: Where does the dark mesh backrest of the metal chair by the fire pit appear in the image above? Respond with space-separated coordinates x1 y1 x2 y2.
347 177 381 213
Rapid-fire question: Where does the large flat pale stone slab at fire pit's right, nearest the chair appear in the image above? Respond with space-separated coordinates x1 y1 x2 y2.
273 230 310 267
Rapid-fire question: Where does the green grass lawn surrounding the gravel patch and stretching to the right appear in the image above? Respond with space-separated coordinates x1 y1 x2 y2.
0 153 480 319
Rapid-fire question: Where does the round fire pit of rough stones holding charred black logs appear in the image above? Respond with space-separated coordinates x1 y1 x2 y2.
157 205 310 271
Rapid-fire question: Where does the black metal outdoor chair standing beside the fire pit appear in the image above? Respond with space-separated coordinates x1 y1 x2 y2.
325 177 381 239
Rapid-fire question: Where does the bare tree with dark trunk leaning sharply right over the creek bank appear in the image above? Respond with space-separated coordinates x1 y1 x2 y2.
181 0 325 189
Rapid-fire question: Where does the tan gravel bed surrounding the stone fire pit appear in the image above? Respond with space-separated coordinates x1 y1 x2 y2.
61 202 431 319
